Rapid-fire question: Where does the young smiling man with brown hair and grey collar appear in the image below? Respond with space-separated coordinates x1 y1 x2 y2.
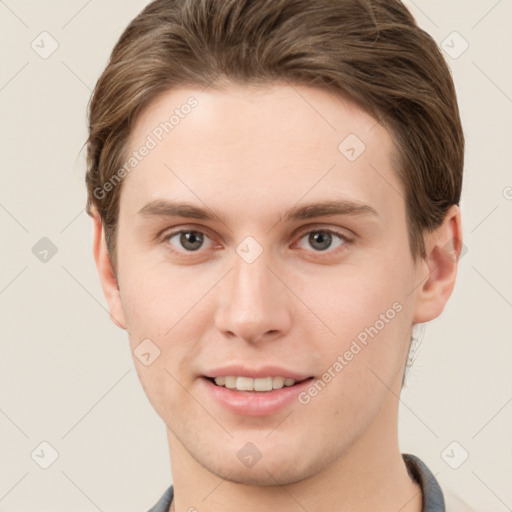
86 0 472 512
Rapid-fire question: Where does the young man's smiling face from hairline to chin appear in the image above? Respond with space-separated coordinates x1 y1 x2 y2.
99 84 440 485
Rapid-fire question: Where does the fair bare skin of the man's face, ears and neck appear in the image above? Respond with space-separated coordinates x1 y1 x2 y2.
94 83 461 512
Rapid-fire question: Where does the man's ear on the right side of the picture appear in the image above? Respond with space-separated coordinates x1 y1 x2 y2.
413 205 463 323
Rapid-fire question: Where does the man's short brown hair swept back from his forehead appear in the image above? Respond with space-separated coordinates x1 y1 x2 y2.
86 0 464 268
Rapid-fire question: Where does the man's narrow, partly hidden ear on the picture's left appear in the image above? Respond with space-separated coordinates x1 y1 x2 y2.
91 210 126 329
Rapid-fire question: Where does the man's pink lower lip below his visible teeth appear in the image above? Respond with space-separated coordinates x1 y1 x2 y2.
201 377 313 416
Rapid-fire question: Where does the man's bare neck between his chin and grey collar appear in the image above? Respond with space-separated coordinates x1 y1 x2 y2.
167 376 422 512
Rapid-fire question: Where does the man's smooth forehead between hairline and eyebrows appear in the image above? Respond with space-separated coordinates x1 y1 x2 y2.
121 83 402 222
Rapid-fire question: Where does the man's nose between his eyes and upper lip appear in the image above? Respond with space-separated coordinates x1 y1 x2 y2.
215 251 293 344
